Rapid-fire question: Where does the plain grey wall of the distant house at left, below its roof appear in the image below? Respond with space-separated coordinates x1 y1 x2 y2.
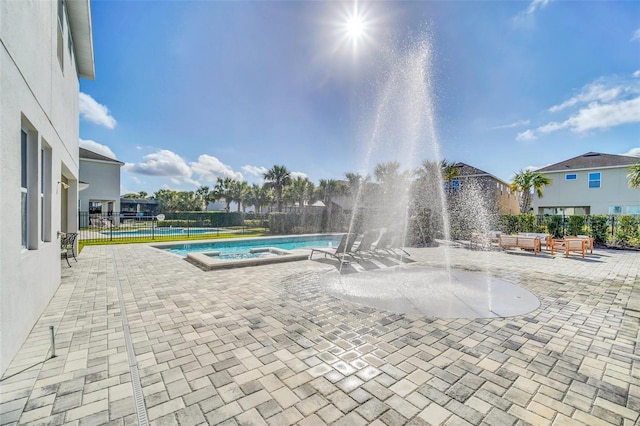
79 158 120 213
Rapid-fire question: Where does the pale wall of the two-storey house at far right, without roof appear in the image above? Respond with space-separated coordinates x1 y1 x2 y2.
533 166 640 214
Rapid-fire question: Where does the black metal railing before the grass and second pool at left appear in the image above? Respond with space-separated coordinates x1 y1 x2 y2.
78 212 269 243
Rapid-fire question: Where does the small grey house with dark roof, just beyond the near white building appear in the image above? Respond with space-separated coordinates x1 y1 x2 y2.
78 148 124 228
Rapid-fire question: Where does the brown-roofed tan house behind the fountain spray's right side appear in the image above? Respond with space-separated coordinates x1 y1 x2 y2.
445 163 520 214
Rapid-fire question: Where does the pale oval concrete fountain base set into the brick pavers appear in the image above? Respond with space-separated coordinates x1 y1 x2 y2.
322 265 540 318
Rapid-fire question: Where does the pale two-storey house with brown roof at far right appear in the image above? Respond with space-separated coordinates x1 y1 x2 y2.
533 152 640 215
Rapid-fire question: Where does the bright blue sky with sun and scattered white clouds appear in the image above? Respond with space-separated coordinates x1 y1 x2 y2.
79 0 640 194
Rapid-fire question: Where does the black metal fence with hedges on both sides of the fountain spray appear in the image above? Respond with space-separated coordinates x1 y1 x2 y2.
78 210 640 245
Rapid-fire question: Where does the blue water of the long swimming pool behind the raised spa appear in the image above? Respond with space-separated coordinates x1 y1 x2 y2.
156 234 342 257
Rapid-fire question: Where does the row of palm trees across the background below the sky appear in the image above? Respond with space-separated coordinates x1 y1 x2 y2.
124 160 640 213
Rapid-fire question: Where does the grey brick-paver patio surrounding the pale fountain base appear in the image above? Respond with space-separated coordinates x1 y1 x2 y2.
0 245 640 426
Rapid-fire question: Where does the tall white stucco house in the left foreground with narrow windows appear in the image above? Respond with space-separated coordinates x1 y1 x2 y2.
0 0 94 374
